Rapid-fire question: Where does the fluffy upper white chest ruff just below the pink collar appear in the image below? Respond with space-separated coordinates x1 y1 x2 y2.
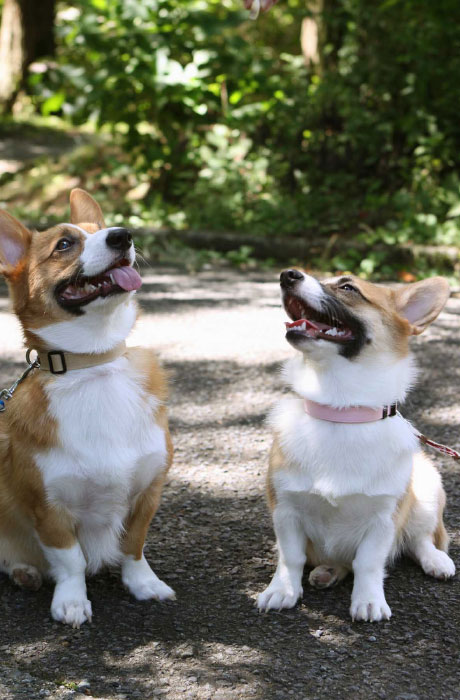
271 398 417 503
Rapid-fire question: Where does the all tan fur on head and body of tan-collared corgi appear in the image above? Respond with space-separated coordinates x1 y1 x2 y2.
0 190 173 587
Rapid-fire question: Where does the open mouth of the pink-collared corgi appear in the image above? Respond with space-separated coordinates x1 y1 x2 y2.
283 294 355 343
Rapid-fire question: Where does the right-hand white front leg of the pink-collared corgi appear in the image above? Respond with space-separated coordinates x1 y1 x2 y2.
350 516 395 622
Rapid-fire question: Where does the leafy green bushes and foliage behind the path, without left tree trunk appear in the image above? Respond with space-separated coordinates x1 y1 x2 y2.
20 0 460 275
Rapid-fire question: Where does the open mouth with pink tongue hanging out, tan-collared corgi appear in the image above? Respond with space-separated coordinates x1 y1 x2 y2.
56 258 142 307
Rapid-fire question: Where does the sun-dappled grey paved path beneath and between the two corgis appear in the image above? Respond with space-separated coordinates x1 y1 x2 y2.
0 269 460 700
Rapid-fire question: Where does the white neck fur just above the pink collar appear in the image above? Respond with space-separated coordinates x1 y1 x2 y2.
283 355 417 408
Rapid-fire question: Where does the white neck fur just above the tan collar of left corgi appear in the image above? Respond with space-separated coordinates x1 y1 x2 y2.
26 298 137 353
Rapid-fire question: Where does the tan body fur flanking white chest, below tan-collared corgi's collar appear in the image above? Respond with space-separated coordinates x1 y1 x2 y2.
0 348 173 571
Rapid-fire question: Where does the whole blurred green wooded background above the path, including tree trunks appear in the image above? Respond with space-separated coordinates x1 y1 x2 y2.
0 0 460 280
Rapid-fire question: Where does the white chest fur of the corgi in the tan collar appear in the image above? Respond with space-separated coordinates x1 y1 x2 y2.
36 357 166 570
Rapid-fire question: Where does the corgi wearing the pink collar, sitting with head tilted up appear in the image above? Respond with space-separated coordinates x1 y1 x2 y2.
258 269 455 622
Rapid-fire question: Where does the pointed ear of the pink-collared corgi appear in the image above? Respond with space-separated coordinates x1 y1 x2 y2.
396 277 450 335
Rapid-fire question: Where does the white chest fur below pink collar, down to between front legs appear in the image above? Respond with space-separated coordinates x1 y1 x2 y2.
271 398 416 564
